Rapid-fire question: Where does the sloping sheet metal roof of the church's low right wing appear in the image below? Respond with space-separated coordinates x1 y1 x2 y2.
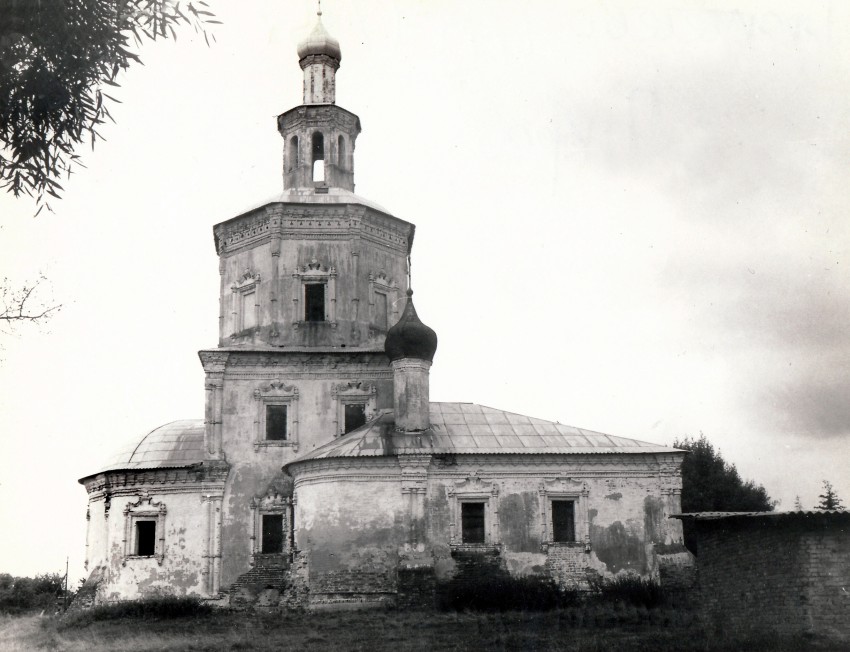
292 403 677 463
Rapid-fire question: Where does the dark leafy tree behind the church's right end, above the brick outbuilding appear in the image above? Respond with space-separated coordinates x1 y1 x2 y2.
673 434 778 554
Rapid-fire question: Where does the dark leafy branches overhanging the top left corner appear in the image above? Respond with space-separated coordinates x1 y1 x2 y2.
0 0 219 211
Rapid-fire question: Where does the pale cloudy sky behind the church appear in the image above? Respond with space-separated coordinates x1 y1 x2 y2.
0 0 850 578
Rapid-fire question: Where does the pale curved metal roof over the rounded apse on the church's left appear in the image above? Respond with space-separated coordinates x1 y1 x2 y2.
80 419 204 477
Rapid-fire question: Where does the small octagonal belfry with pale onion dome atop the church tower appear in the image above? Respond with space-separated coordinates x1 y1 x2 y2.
277 10 360 193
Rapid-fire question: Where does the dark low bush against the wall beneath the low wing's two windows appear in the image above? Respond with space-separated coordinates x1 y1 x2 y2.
438 575 578 612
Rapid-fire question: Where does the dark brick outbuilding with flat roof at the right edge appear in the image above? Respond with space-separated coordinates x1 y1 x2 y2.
678 512 850 641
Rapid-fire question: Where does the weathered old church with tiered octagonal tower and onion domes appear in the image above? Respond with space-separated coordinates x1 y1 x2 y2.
80 14 688 608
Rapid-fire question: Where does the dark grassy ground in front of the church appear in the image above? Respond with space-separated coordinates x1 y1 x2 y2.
0 610 847 652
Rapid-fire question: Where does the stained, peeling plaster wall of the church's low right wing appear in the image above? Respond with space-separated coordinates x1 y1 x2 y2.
290 448 681 602
